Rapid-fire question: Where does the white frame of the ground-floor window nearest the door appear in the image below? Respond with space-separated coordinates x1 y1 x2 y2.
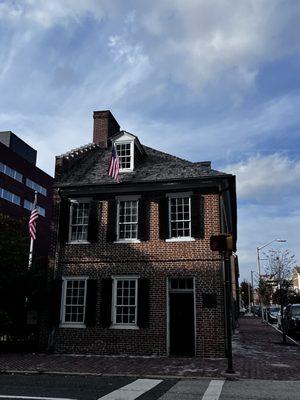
110 275 139 329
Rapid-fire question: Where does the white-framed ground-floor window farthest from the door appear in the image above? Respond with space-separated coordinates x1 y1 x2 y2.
61 277 87 327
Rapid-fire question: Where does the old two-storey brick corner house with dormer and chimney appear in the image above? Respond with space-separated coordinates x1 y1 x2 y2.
50 111 236 357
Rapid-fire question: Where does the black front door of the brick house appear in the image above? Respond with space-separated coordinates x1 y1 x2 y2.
169 293 195 356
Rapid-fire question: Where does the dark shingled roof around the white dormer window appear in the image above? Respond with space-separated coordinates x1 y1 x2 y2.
57 141 228 186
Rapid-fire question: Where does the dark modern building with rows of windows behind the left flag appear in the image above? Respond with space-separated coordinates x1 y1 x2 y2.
0 131 53 257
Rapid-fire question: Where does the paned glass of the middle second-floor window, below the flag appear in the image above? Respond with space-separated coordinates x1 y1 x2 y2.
118 200 138 239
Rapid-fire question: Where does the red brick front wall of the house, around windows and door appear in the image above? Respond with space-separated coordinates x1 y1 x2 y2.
50 194 225 357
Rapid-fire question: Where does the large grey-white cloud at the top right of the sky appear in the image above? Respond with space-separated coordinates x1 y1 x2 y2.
140 0 300 91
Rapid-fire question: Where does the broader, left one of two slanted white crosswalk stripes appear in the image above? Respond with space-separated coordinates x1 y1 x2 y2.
98 379 162 400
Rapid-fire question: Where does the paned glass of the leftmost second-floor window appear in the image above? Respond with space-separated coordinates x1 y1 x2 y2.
70 202 90 242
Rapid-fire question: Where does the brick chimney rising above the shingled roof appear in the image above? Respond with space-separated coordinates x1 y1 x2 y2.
93 110 120 147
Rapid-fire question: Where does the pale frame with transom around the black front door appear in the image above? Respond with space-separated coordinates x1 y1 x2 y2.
166 276 197 357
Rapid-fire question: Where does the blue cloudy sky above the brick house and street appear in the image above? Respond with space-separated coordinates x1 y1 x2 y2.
0 0 300 280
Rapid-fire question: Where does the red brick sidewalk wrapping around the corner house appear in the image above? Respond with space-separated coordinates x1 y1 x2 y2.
0 317 300 380
